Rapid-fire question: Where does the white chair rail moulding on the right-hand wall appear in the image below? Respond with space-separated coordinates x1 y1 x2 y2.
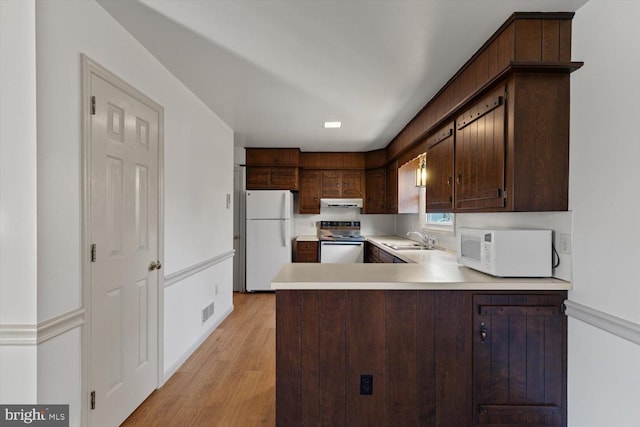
564 300 640 345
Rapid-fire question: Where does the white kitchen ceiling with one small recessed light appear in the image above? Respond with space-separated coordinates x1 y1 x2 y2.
98 0 587 151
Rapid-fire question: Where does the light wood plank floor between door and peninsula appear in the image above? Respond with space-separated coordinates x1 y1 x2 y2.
122 293 276 427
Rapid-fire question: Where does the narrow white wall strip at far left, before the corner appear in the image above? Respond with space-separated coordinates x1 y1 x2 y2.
0 0 37 403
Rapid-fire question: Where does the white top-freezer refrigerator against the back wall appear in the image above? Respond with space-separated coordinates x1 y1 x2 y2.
245 190 293 292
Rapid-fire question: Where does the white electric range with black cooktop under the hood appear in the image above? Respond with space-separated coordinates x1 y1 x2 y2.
318 221 364 264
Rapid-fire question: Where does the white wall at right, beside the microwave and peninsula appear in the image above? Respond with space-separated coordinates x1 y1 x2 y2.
568 0 640 427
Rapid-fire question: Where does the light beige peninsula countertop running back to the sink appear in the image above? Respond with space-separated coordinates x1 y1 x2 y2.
271 236 571 291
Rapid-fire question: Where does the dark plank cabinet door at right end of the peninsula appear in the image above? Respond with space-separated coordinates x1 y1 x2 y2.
473 292 567 427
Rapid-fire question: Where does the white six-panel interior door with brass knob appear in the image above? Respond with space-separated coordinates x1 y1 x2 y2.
88 61 162 426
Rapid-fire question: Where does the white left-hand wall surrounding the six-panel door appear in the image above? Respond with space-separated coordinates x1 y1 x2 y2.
0 0 238 426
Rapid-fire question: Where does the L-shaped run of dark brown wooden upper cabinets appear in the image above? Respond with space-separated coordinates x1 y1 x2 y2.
247 12 582 214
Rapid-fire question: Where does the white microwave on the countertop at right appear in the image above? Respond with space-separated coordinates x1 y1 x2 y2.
457 227 553 277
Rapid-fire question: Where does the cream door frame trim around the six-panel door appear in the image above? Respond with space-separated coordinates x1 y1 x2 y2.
80 54 165 426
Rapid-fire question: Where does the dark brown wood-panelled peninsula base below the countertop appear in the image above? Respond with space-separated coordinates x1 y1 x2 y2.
276 290 566 427
